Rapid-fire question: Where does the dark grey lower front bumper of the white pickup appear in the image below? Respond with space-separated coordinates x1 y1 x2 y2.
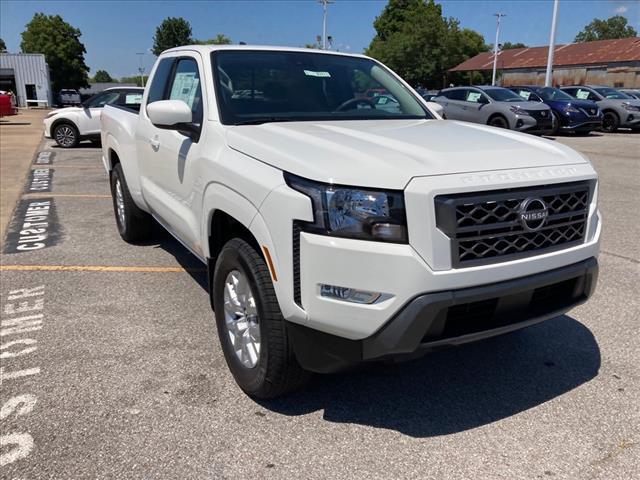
287 257 598 373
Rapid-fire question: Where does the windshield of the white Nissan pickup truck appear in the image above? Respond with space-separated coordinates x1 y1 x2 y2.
212 50 432 124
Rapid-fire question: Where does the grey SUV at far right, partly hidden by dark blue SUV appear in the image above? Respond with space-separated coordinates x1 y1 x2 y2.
560 85 640 132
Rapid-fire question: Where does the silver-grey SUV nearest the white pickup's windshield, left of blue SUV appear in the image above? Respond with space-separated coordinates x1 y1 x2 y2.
432 86 554 135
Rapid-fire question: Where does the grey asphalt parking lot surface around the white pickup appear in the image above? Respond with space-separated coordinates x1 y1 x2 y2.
0 125 640 479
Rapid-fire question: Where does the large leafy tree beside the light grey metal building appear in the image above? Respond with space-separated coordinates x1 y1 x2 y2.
20 13 89 91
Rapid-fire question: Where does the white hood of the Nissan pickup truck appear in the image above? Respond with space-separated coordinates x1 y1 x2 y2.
227 120 587 189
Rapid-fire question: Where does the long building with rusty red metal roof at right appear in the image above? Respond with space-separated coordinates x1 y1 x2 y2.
449 37 640 88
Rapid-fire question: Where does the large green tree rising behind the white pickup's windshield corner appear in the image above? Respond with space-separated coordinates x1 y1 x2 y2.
366 0 487 88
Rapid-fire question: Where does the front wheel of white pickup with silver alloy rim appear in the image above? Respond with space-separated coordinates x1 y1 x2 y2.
211 238 311 399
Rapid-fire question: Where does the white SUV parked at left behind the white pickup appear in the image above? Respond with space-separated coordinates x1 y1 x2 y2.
44 87 144 148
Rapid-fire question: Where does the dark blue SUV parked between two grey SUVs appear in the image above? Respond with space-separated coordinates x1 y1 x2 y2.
509 86 602 134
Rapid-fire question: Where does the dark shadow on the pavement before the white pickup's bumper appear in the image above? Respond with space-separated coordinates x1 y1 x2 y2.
260 315 600 437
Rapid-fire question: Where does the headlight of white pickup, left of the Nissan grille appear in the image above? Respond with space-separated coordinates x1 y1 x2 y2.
285 173 408 243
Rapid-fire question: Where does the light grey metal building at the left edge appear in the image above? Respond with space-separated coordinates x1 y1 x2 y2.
0 53 53 107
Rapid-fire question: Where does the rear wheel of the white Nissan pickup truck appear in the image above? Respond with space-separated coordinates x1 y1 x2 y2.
111 163 153 244
